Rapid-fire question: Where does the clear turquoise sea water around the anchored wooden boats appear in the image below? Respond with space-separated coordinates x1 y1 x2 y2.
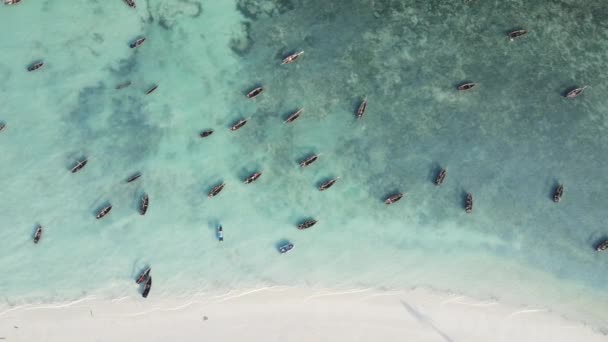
0 0 608 326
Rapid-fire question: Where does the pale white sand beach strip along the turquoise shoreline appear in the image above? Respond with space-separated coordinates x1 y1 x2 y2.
0 288 606 342
